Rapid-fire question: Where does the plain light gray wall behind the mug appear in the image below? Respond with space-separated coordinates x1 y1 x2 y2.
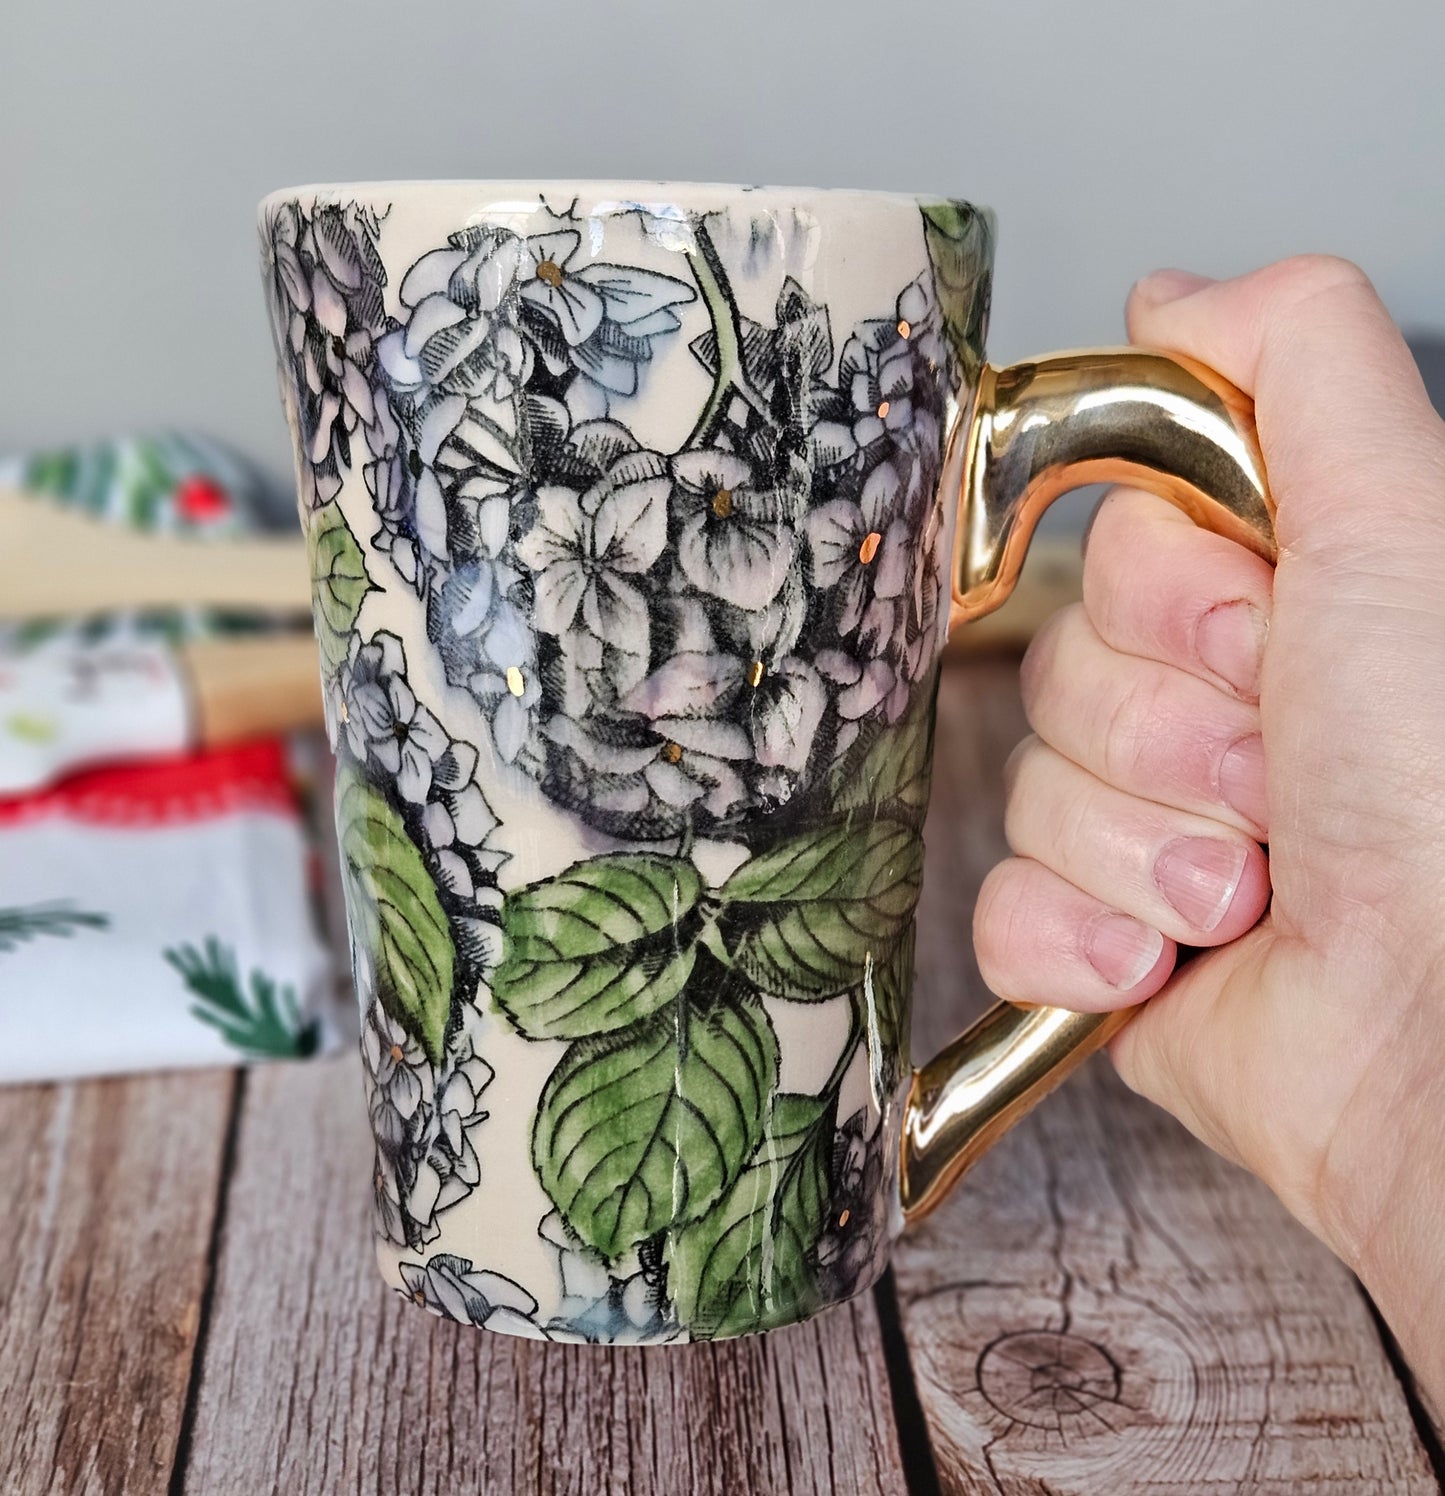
0 0 1445 471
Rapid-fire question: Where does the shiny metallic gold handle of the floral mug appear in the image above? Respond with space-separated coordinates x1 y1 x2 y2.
899 349 1276 1221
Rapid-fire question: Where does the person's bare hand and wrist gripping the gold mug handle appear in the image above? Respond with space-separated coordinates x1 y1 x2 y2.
975 256 1445 1408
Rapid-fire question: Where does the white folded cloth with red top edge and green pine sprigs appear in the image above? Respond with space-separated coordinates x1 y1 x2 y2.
0 741 338 1082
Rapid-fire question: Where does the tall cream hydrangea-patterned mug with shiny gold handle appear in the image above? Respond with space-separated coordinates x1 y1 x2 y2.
260 183 1273 1343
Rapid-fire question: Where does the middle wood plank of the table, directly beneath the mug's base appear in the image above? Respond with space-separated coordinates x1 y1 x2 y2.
185 1058 906 1496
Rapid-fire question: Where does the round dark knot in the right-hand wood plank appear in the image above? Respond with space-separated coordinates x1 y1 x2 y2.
977 1330 1120 1432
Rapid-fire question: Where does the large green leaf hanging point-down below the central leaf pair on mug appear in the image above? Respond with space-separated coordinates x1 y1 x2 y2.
533 981 778 1258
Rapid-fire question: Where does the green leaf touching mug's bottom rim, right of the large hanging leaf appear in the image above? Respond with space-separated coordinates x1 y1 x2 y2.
669 1094 833 1339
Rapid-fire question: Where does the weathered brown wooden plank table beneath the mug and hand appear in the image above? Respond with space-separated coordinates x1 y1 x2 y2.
0 660 1442 1496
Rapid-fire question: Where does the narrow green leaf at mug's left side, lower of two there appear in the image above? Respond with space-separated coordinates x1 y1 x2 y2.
337 773 455 1065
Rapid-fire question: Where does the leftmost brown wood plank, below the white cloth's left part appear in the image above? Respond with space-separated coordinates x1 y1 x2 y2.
0 1071 235 1496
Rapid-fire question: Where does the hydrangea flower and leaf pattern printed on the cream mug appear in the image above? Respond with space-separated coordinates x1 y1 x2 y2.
266 187 987 1342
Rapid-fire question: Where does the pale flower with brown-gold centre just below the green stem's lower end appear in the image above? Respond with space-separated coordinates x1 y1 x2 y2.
672 449 794 610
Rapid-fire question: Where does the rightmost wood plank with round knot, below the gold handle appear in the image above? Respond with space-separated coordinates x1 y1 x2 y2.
895 663 1438 1496
